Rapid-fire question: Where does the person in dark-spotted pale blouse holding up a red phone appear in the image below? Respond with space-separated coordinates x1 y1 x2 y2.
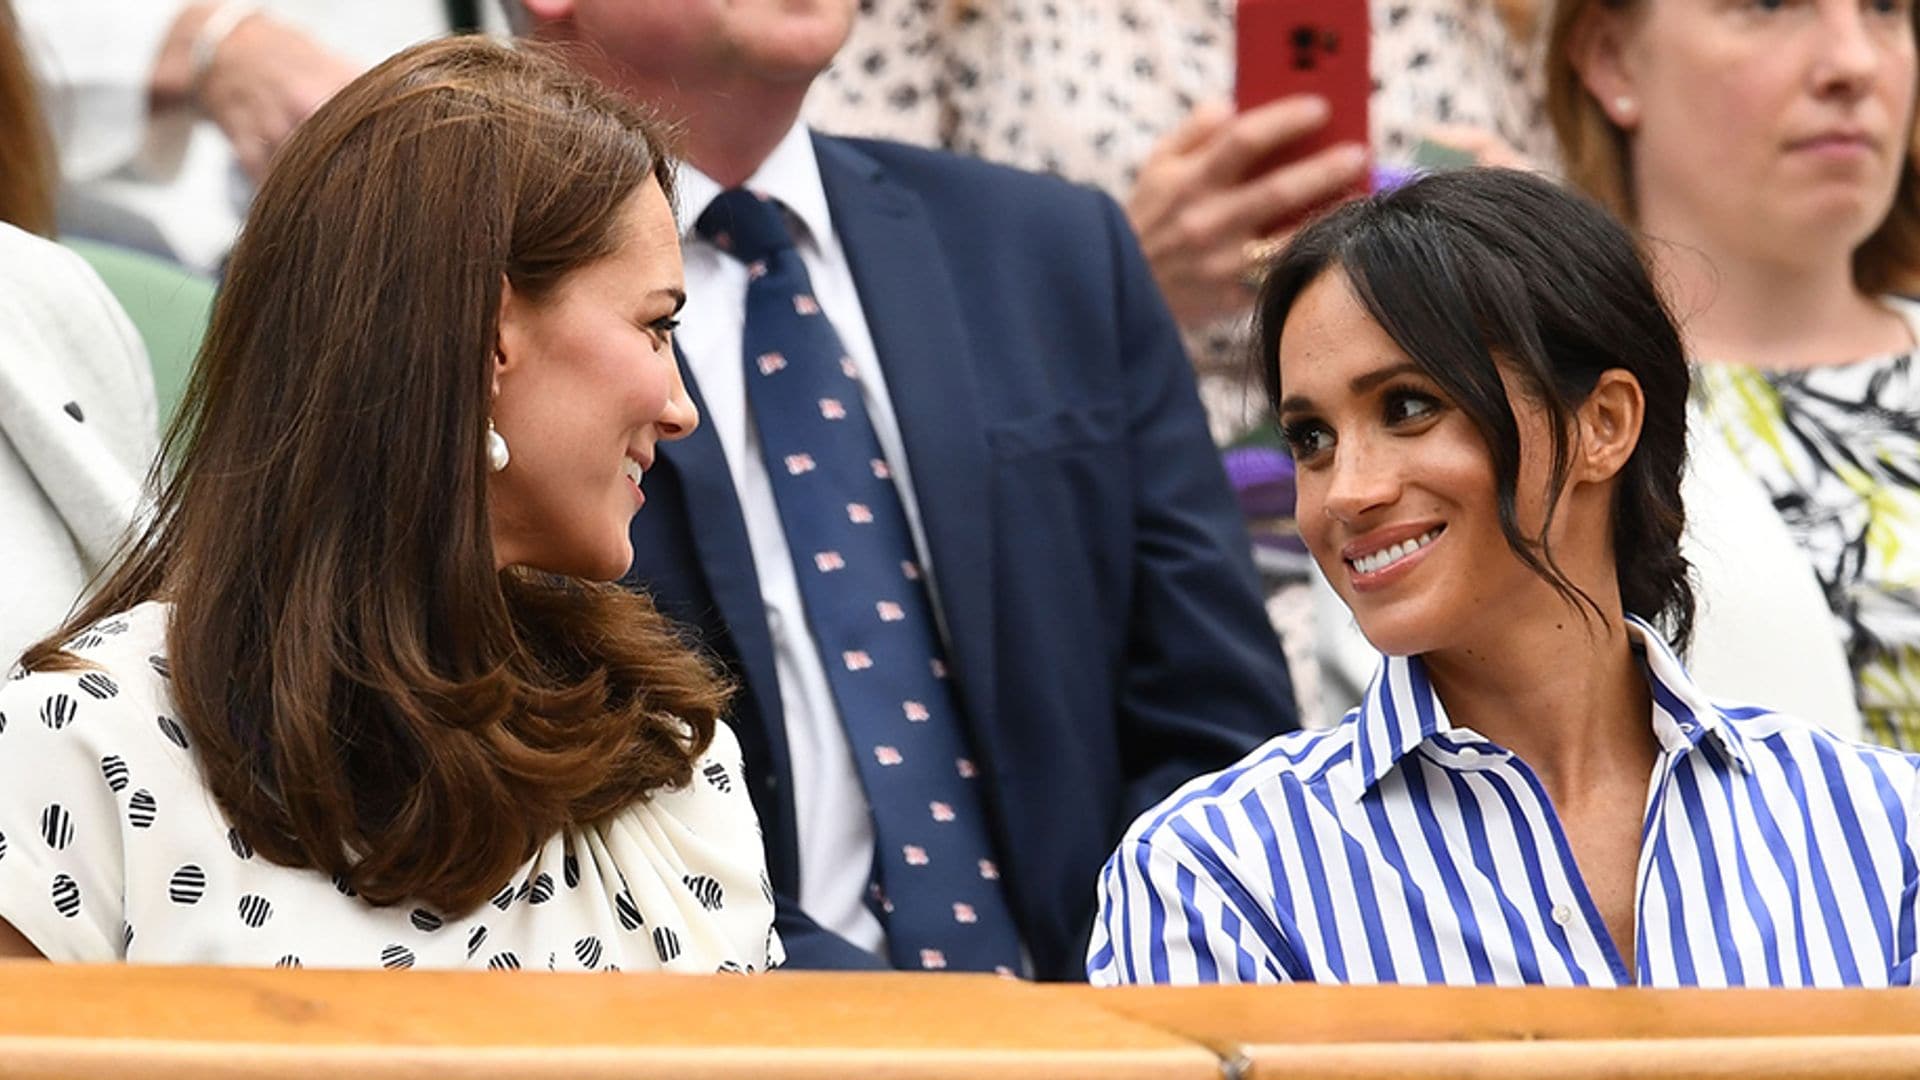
804 0 1549 440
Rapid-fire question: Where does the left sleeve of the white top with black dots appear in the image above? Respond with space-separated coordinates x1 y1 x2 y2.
0 671 136 963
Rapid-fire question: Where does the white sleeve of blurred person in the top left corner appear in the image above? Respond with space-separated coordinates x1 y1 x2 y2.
13 0 184 183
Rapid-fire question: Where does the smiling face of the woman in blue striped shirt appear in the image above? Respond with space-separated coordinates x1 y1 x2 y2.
1279 269 1582 655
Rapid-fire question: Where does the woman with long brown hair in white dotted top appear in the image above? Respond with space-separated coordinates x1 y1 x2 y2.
0 40 780 972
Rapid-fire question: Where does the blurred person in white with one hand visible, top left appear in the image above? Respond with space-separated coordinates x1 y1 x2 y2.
15 0 499 273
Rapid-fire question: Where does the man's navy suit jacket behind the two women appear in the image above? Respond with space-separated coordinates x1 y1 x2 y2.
628 136 1296 978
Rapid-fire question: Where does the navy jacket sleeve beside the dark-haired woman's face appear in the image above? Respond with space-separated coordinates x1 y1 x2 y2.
1102 189 1300 818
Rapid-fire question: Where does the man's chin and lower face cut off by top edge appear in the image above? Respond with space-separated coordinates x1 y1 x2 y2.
560 0 856 88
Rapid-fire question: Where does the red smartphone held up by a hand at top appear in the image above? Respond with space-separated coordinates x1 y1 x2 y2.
1235 0 1373 229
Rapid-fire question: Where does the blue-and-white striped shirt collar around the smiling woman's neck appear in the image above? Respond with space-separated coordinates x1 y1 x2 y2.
1354 615 1751 799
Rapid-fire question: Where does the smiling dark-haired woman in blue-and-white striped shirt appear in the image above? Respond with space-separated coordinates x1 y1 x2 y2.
1089 171 1920 986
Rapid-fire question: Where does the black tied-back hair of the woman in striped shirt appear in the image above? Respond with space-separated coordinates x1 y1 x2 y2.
1254 169 1693 648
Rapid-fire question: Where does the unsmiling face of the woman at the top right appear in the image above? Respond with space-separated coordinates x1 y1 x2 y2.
1584 0 1914 261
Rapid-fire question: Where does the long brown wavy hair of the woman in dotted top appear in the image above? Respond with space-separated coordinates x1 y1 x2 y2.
23 38 726 913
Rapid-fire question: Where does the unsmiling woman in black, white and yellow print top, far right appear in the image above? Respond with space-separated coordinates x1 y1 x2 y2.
1548 0 1920 748
